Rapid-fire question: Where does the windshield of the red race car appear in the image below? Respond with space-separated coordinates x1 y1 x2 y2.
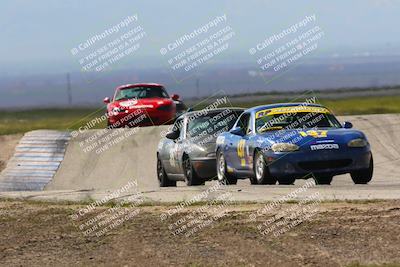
115 86 169 100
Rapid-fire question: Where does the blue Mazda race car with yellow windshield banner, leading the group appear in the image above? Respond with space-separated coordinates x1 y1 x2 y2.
216 103 373 184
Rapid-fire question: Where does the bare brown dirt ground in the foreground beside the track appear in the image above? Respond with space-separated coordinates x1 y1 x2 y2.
0 201 400 266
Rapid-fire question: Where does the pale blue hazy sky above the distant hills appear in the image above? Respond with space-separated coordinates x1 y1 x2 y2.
0 0 400 74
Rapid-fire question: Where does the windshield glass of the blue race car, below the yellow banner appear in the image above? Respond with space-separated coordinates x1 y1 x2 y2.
256 112 341 133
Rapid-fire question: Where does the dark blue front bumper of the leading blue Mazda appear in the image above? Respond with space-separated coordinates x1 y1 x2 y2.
265 147 372 179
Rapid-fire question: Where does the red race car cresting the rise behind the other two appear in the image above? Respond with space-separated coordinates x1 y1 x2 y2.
104 83 181 128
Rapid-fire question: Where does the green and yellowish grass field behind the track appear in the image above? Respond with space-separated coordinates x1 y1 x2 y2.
0 96 400 135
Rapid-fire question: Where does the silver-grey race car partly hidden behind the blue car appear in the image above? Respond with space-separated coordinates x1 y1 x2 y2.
157 108 244 187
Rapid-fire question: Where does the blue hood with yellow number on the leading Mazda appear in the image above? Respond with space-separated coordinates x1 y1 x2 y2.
257 128 365 147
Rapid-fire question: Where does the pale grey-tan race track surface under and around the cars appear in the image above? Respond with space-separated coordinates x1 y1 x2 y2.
0 114 400 202
